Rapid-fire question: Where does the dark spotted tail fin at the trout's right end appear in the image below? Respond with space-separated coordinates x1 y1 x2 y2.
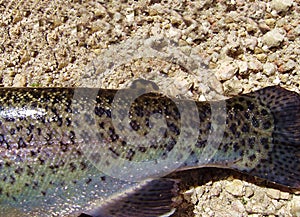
250 86 300 188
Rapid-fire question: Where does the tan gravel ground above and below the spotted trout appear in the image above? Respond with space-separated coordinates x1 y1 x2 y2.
0 0 300 217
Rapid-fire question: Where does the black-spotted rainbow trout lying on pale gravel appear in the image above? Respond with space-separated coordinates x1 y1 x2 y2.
0 82 300 217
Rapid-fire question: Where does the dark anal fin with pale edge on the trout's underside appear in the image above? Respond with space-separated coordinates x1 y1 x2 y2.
82 178 178 217
